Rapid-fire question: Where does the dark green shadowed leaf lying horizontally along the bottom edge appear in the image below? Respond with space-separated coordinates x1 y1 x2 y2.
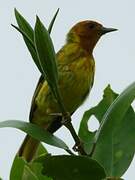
37 155 106 180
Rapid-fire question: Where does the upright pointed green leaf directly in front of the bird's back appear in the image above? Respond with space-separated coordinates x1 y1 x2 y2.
34 17 58 94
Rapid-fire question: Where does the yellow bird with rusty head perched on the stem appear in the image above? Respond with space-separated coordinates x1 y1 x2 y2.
18 20 117 162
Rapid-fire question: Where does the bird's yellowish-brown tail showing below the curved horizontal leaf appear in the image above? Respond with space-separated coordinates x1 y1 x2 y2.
18 135 39 162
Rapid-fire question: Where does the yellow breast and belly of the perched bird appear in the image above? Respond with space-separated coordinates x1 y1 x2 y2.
60 56 95 111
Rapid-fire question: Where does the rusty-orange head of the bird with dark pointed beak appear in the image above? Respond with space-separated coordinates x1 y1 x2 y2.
67 20 117 52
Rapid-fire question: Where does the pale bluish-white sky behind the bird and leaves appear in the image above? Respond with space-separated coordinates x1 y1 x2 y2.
0 0 135 180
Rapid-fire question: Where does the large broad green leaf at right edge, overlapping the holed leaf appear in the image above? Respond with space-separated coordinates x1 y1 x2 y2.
93 83 135 177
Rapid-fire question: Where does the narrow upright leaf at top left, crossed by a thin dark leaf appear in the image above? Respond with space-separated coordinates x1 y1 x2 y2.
14 9 42 73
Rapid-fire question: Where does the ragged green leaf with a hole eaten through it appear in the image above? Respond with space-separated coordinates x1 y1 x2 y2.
78 85 117 154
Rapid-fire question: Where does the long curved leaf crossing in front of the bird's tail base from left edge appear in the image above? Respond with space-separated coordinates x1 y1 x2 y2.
0 120 68 150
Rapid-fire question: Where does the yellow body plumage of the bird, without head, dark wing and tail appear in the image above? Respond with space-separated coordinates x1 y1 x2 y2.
32 43 94 126
